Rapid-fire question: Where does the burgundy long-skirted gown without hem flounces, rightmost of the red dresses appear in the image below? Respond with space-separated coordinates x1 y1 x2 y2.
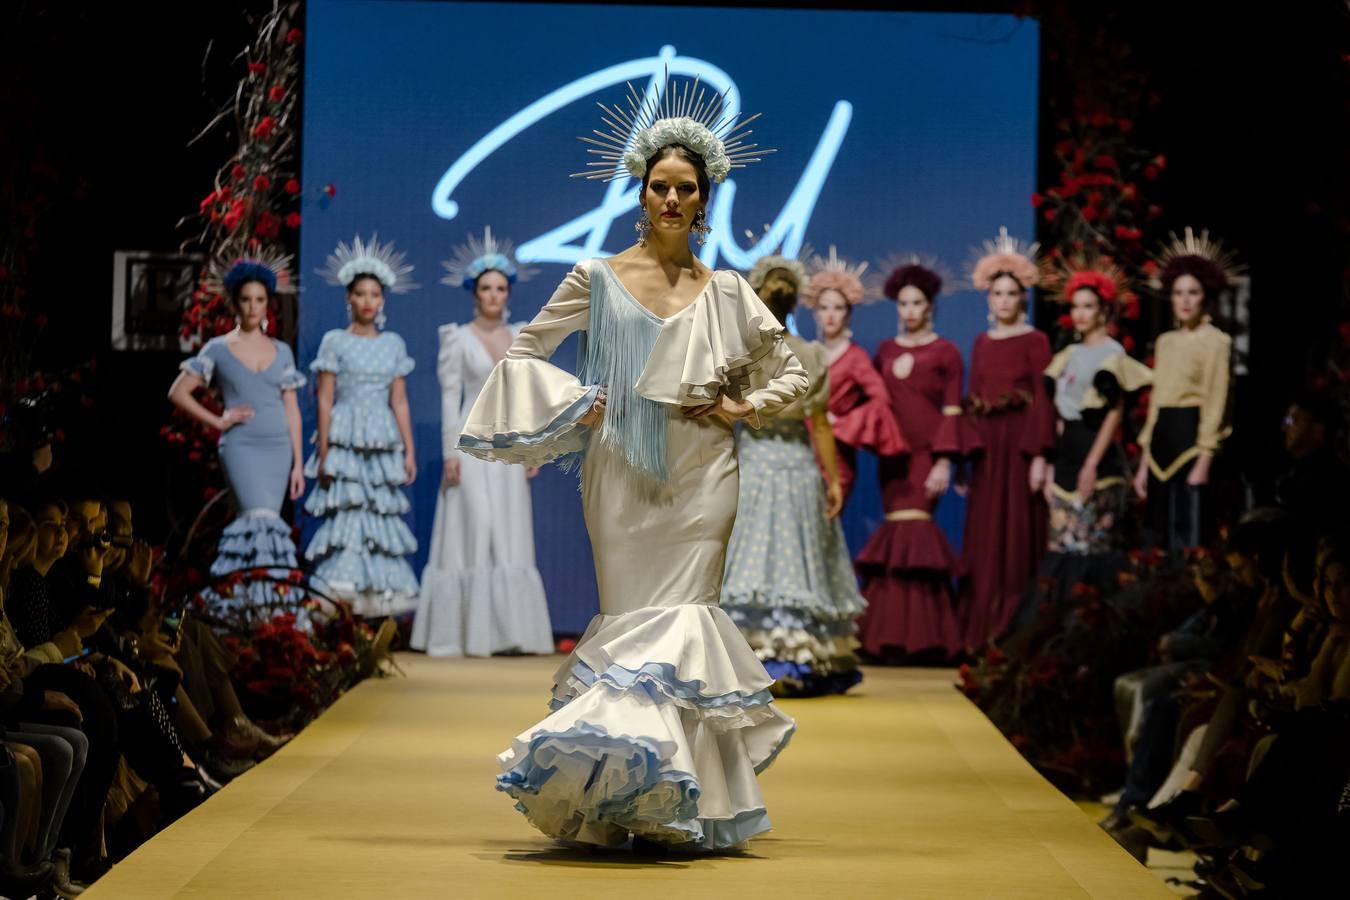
961 329 1054 646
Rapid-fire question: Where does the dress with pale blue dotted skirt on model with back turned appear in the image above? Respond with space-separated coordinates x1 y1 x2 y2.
722 335 867 696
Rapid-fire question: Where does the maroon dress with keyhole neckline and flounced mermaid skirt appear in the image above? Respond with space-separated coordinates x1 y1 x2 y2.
857 337 977 660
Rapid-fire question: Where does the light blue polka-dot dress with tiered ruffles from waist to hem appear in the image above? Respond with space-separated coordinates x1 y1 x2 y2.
305 329 419 617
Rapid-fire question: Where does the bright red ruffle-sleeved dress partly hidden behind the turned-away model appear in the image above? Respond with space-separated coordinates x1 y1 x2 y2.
828 343 907 501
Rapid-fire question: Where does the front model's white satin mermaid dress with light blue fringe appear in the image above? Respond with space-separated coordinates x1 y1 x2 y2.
460 260 807 850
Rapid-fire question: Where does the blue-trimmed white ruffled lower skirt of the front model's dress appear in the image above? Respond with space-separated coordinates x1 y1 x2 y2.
498 604 795 851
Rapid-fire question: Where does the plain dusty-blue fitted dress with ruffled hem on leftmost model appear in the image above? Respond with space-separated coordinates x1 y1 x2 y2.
180 337 305 611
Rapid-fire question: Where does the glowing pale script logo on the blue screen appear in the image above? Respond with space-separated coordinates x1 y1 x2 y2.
431 46 853 269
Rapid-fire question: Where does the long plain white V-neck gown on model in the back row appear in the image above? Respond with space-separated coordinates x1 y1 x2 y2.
412 324 554 656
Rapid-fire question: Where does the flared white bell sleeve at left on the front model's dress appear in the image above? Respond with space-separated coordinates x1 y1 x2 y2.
459 263 599 466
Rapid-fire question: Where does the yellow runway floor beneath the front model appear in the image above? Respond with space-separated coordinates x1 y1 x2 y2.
85 656 1172 900
